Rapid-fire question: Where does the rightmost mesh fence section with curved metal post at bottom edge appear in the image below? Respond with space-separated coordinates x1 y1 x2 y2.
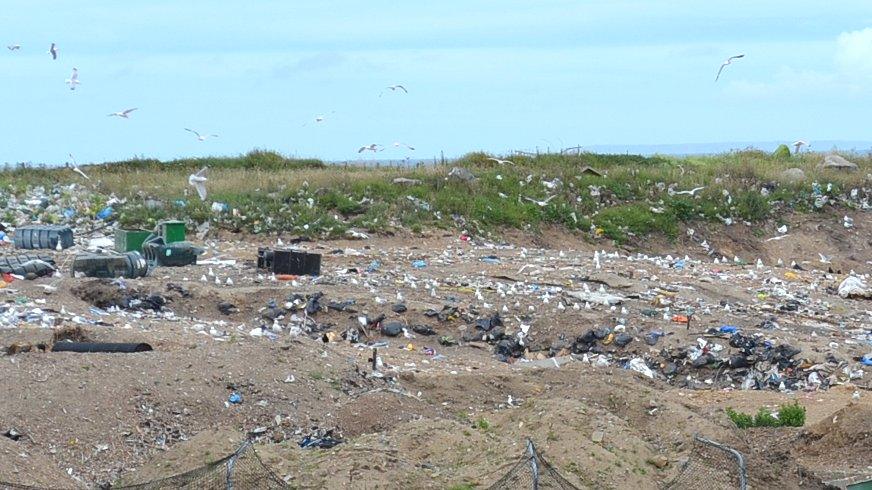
666 436 748 490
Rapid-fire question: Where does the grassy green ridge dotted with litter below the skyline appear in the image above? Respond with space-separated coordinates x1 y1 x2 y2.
0 151 872 242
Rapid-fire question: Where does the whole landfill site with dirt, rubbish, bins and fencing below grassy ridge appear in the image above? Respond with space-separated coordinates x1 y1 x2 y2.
0 160 872 490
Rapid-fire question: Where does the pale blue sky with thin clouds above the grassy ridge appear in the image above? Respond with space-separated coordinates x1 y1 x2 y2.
0 0 872 165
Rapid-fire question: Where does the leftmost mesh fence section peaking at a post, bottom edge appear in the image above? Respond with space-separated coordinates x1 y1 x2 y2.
0 441 289 490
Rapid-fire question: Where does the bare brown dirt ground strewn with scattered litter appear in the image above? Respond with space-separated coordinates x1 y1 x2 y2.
0 210 872 488
